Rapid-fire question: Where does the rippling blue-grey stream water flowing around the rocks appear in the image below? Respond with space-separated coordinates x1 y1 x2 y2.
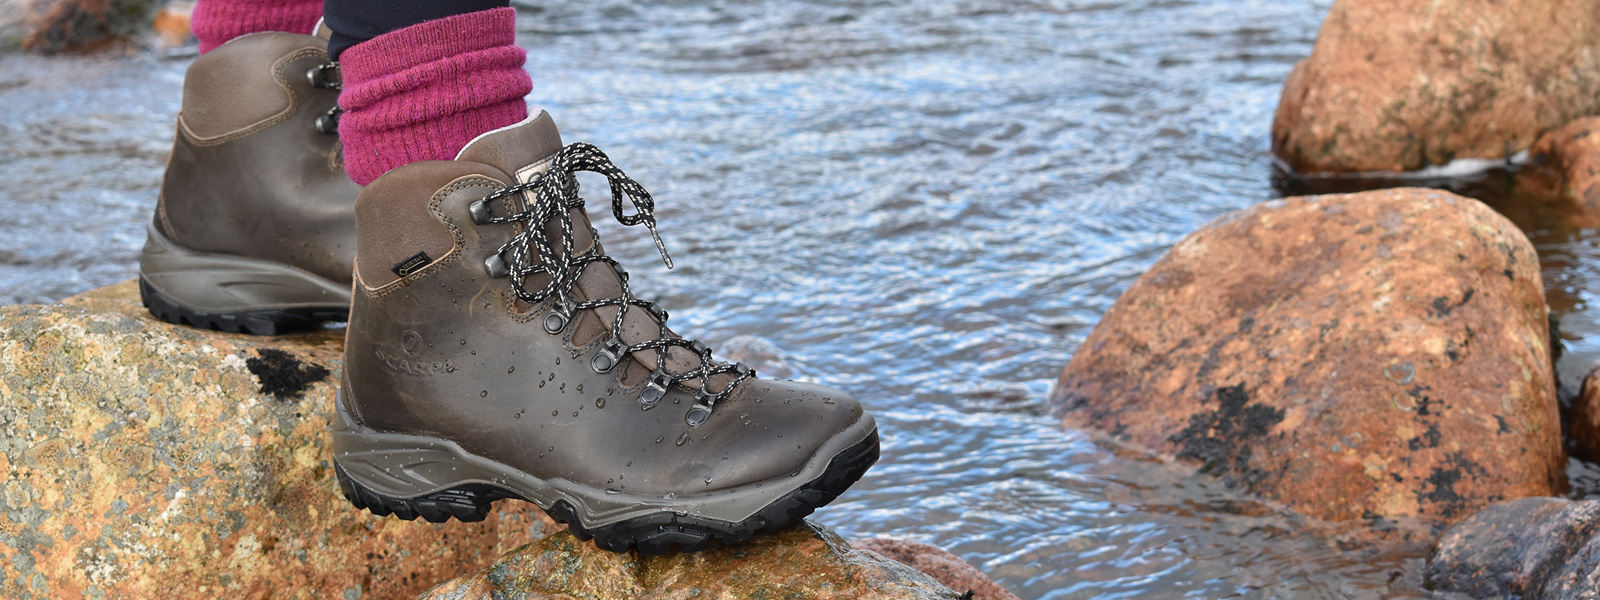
0 0 1600 600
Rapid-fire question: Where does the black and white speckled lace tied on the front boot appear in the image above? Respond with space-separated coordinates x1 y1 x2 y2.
470 142 755 427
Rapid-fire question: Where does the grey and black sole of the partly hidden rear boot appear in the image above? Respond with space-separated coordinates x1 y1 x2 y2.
139 224 350 336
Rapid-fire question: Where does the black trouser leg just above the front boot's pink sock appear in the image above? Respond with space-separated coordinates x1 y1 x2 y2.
322 0 510 61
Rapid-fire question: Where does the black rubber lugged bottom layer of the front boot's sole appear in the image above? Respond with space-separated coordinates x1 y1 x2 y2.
333 430 878 555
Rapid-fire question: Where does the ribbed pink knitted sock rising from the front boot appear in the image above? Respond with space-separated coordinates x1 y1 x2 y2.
339 8 533 186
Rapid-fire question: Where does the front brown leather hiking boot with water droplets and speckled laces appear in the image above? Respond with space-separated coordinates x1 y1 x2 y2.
333 114 878 554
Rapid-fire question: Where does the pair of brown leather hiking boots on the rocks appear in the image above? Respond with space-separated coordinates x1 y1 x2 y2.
139 32 878 554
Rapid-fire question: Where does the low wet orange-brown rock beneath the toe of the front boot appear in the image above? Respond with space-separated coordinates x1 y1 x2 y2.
422 522 960 600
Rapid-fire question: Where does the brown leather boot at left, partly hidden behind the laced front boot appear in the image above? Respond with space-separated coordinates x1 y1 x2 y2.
139 32 362 334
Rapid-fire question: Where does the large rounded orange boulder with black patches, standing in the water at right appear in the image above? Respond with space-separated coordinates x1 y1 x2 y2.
1051 189 1566 525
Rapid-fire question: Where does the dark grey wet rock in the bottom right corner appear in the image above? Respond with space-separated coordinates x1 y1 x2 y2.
1427 498 1600 600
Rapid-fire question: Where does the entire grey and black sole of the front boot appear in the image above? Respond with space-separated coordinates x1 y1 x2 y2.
333 392 878 555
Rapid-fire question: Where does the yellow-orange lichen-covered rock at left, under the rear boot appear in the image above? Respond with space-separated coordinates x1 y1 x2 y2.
0 282 557 598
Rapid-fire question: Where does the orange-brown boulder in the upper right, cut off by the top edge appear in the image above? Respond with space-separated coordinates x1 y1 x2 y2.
1272 0 1600 173
